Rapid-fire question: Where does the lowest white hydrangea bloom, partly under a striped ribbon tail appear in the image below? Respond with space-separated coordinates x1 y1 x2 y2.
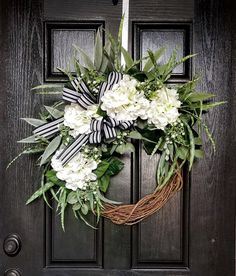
51 150 99 191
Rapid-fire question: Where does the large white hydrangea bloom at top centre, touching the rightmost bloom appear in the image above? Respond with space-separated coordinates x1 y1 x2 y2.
101 75 149 120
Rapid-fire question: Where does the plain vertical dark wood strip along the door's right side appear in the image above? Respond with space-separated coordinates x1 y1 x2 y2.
190 0 236 276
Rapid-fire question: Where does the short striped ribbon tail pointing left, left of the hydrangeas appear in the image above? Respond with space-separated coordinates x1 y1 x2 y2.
33 117 64 139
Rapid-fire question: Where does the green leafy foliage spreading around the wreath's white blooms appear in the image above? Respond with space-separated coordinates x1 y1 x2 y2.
9 19 224 230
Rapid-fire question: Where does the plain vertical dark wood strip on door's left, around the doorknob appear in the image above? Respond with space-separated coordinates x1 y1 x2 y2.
0 0 44 275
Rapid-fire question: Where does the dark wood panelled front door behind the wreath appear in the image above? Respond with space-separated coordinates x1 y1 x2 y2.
0 0 236 276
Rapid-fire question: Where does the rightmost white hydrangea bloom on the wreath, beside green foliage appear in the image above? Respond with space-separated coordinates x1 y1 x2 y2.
147 87 181 130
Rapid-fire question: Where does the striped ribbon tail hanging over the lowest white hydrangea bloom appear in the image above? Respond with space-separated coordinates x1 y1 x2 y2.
57 134 88 166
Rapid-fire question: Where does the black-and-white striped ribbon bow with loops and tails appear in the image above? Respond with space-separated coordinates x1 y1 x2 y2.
33 72 133 165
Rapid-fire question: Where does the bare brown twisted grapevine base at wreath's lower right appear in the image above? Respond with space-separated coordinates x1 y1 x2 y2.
102 172 183 225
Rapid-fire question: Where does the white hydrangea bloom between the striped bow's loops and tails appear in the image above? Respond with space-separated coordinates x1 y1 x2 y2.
64 103 99 137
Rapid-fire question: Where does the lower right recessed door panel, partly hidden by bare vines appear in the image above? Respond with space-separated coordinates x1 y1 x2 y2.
134 151 183 266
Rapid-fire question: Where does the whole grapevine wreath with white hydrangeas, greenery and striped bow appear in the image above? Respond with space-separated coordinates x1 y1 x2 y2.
10 21 223 229
